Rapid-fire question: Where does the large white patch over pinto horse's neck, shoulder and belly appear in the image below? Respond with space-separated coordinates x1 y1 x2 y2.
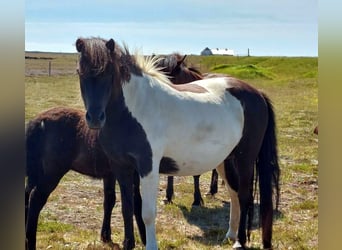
123 66 244 175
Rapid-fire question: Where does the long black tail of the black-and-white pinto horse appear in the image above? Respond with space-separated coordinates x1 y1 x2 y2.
256 94 280 247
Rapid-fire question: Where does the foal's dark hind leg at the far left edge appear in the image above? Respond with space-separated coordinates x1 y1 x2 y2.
26 173 64 250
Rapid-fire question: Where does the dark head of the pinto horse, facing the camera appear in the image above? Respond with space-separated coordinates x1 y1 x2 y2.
76 38 130 129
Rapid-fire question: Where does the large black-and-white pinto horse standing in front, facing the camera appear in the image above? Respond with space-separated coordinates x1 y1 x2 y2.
76 38 280 250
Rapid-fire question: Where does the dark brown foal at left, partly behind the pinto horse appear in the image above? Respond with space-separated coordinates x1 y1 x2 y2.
25 107 145 250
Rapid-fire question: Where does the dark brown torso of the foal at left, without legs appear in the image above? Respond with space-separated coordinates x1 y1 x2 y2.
26 107 108 177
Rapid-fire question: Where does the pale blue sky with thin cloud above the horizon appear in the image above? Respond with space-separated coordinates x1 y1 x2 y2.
25 0 318 56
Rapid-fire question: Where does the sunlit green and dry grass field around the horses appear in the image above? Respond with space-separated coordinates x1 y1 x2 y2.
25 53 318 250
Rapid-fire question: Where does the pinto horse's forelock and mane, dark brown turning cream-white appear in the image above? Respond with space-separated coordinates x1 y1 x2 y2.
76 37 170 84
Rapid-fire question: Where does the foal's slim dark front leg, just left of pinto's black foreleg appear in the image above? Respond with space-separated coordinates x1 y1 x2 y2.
101 174 116 242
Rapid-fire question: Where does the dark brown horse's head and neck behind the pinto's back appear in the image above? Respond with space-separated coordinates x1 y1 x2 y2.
158 53 203 84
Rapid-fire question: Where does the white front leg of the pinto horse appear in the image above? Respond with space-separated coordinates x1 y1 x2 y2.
140 169 160 250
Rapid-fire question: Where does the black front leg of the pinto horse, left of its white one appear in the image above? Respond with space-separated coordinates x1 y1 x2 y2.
117 165 135 250
